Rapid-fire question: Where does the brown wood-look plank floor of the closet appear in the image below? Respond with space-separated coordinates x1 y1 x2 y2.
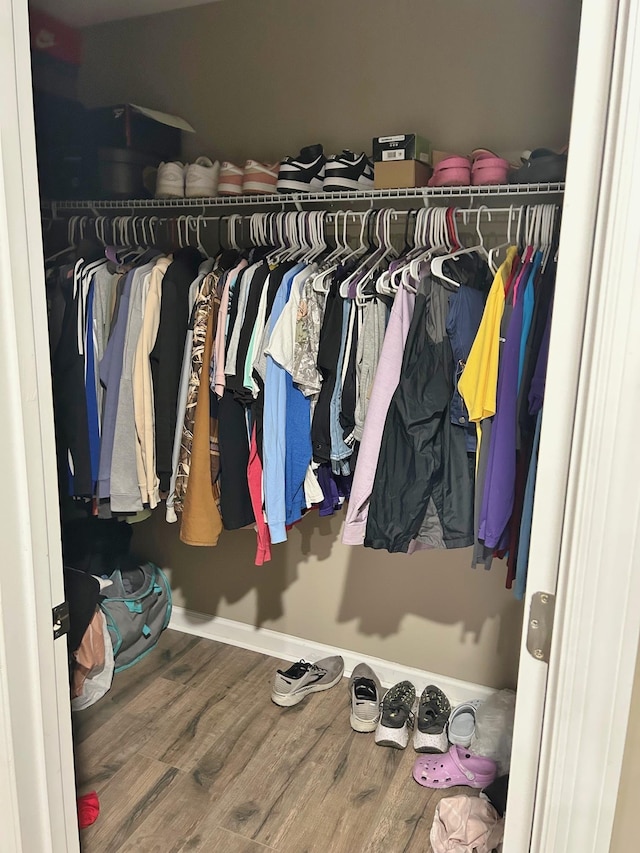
74 631 472 853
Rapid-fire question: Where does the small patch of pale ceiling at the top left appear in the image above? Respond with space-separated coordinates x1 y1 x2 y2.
29 0 222 27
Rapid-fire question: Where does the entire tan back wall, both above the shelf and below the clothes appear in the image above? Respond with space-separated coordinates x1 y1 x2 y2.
80 0 579 686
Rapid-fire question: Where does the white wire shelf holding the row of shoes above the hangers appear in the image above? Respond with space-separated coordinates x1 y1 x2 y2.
42 183 564 216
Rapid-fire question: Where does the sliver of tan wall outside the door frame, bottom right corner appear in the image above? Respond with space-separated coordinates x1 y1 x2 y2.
609 644 640 853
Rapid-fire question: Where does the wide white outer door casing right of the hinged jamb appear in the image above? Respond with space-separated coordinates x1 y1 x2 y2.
531 0 640 853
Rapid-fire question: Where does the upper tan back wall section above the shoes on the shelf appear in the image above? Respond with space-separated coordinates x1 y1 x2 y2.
80 0 580 168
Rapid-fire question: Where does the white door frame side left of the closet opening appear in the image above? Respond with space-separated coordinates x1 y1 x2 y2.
0 0 79 853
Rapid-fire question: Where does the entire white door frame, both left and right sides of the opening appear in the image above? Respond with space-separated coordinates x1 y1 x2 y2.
0 0 640 853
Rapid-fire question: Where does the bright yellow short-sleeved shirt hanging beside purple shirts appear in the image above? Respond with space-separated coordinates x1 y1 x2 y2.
458 246 518 461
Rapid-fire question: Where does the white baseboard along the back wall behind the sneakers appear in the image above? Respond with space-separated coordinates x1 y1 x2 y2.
169 606 495 705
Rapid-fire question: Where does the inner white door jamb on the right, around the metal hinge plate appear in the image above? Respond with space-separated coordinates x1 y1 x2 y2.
504 0 616 853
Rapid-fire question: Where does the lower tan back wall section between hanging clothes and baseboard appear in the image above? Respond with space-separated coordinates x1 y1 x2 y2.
134 512 522 687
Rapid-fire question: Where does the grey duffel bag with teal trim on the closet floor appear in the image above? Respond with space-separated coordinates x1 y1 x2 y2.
100 563 171 672
